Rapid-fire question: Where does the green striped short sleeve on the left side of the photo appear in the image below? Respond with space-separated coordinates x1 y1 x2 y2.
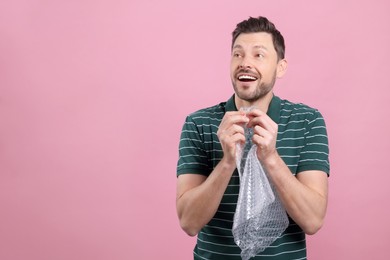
177 116 210 176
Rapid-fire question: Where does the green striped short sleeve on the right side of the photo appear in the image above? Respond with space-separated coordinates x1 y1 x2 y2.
297 110 330 175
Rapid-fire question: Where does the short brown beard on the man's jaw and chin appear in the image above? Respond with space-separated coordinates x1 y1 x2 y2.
232 71 276 103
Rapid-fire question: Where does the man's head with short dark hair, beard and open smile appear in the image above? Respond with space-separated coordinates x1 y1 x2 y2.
230 17 287 105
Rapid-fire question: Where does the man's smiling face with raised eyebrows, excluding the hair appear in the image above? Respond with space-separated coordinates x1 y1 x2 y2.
230 32 279 102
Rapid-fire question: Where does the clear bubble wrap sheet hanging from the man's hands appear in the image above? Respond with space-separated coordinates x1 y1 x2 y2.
233 114 289 260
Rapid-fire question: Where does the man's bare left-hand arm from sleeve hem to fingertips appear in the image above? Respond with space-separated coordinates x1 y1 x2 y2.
176 112 248 236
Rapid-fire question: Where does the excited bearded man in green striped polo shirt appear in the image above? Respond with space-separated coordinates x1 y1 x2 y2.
176 17 329 260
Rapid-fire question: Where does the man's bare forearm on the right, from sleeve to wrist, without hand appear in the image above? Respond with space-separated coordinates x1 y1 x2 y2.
263 155 327 234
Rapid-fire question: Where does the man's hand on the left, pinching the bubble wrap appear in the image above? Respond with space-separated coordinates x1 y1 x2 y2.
217 111 249 164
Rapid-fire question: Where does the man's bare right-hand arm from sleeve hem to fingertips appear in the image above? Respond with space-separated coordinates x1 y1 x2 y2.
248 109 328 234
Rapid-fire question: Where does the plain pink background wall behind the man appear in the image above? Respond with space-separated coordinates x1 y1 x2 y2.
0 0 390 260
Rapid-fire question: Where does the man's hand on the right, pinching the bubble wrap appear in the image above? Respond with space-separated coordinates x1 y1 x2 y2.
247 109 278 162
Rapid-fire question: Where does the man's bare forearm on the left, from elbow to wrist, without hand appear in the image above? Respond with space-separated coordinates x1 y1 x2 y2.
177 160 235 236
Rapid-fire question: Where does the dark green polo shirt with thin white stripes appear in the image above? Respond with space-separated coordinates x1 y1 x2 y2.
177 95 329 260
